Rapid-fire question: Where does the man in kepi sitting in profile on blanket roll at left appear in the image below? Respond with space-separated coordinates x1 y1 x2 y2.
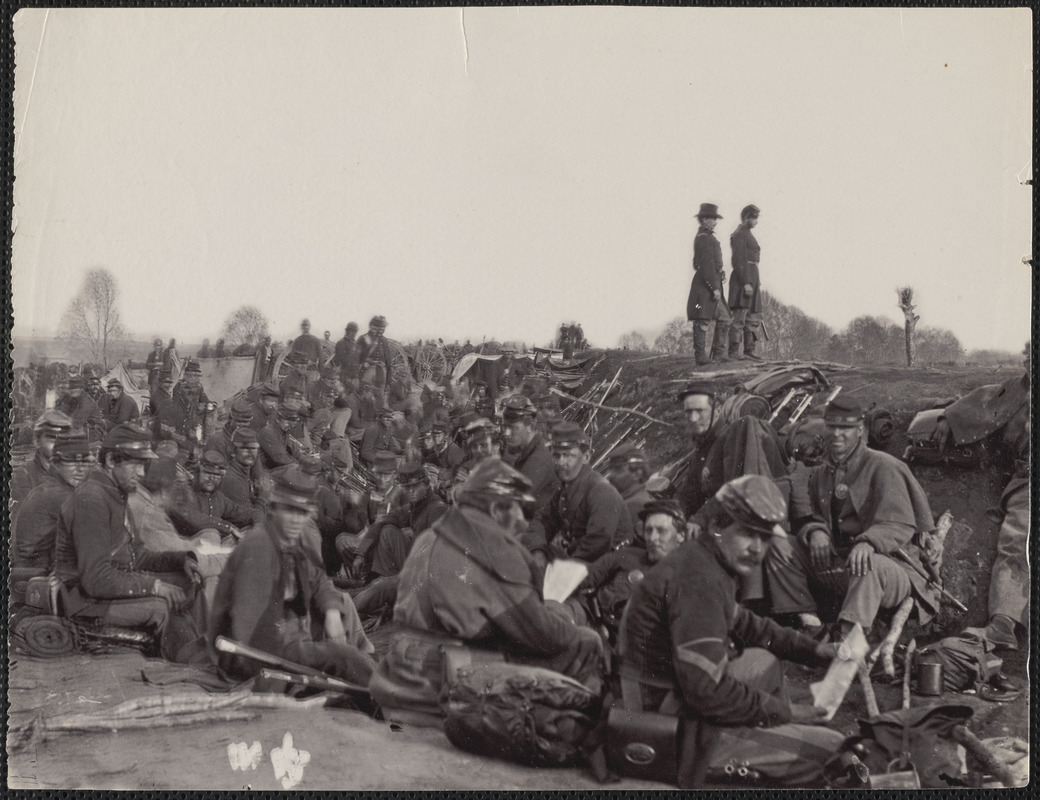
54 423 202 661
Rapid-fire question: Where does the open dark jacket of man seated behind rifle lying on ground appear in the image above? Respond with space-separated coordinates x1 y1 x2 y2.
208 522 346 676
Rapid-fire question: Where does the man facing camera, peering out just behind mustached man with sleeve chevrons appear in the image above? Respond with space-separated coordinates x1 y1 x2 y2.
567 498 686 641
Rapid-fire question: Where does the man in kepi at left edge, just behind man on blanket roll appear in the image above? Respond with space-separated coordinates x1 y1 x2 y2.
10 431 97 574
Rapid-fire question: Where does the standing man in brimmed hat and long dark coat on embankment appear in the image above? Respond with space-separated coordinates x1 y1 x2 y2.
686 203 731 365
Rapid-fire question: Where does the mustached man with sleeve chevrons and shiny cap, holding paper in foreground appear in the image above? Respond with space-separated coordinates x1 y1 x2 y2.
618 475 843 789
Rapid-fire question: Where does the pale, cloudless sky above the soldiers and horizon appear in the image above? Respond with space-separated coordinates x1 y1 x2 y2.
11 7 1033 352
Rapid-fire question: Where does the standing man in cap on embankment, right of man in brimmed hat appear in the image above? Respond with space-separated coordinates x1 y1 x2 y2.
729 205 762 361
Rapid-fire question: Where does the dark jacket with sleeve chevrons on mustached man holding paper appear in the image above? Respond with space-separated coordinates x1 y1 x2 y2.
618 540 815 789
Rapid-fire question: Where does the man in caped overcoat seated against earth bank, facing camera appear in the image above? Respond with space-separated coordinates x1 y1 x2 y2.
765 396 937 635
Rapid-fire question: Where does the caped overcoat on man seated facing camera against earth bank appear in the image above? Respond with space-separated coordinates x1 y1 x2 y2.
799 443 938 622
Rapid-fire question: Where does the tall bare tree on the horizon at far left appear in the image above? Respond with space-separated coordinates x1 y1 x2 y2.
58 268 129 370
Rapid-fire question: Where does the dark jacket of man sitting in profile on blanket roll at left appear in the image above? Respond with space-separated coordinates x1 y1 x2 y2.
54 470 185 617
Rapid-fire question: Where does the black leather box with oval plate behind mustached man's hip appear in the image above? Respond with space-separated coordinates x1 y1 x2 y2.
606 707 679 785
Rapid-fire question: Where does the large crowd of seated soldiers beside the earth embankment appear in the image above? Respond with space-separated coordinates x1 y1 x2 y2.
12 345 1023 788
